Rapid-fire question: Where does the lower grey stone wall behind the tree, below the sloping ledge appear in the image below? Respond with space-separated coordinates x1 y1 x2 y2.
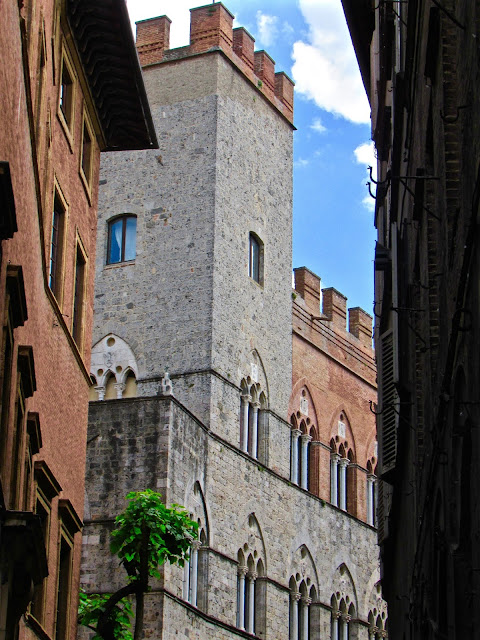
82 397 378 640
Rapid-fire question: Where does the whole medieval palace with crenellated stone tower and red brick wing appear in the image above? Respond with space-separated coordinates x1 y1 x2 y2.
81 3 387 640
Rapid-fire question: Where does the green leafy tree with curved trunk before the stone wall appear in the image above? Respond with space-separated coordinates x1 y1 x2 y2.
79 489 198 640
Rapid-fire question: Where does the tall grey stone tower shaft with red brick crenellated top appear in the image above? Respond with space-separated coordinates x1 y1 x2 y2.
89 4 293 450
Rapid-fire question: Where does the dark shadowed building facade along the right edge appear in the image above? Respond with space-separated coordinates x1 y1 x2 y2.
343 0 480 640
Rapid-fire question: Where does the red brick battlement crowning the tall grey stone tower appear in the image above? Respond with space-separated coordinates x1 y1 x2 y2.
136 2 294 123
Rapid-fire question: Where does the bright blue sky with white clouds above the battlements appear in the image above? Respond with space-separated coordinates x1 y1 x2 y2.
127 0 375 313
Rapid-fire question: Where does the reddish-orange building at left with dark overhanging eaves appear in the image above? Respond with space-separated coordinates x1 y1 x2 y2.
0 0 156 640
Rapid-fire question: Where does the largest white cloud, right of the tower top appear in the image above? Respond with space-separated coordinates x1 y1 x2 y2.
292 0 370 124
